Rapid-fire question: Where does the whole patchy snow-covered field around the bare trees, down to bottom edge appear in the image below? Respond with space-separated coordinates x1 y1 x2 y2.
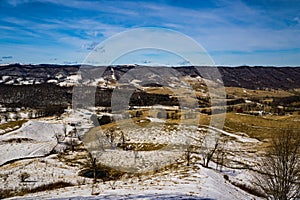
0 110 259 200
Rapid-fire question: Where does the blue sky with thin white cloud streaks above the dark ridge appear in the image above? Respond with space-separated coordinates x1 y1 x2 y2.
0 0 300 66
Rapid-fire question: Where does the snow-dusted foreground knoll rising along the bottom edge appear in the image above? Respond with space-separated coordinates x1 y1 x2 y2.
6 162 259 200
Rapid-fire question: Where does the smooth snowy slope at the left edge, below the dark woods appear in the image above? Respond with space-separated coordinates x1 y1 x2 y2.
0 121 63 165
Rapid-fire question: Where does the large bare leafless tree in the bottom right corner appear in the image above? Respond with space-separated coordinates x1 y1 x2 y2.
254 130 300 200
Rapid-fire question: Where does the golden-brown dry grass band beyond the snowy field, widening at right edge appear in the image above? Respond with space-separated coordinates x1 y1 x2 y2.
91 109 300 144
